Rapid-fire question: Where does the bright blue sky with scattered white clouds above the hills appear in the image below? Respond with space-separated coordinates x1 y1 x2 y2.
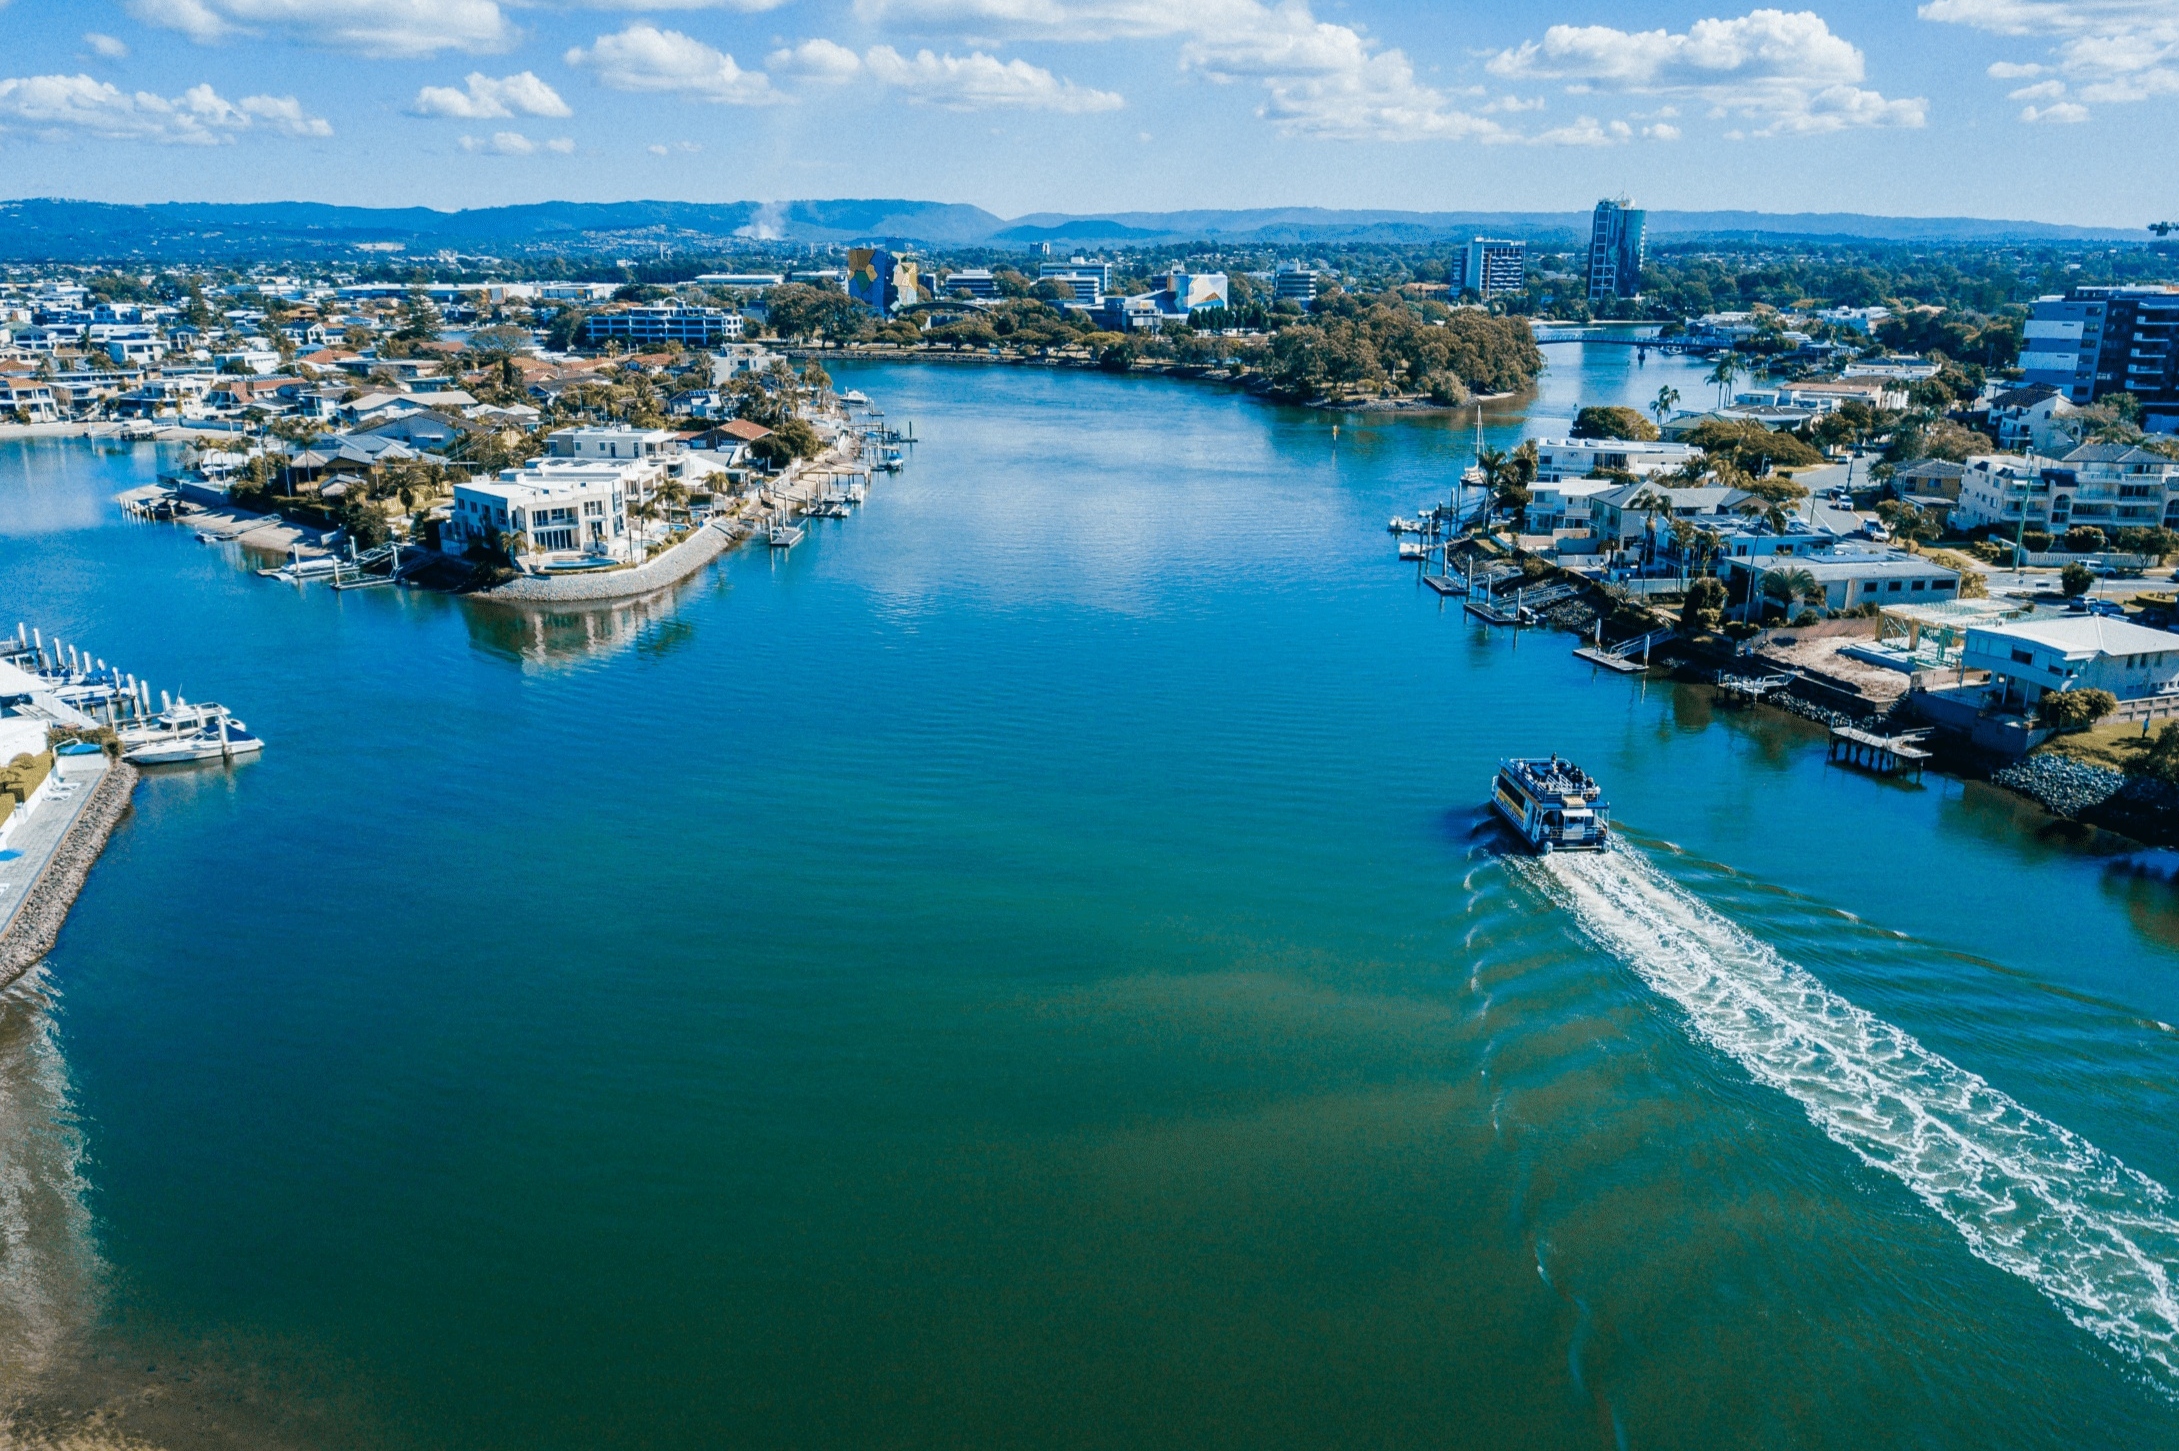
0 0 2179 227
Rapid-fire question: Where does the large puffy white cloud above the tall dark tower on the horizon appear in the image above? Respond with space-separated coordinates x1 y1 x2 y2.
1488 9 1928 135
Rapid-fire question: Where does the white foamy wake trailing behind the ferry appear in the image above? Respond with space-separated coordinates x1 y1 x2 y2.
1534 850 2179 1399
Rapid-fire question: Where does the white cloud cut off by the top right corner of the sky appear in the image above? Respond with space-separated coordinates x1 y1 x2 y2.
1918 0 2179 124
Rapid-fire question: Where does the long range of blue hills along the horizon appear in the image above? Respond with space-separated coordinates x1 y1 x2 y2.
0 198 2148 261
